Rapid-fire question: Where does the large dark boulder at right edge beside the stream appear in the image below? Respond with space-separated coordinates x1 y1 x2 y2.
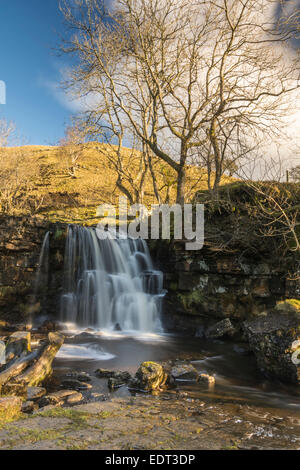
243 309 300 384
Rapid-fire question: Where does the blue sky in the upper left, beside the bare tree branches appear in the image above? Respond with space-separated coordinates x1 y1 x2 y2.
0 0 75 145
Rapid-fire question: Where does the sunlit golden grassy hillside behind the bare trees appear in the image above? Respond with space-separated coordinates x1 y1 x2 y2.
0 143 232 224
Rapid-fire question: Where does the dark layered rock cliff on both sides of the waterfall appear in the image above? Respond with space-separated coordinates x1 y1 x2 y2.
0 217 300 333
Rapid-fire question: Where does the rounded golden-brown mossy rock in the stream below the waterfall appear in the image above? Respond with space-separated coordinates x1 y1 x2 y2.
130 362 169 392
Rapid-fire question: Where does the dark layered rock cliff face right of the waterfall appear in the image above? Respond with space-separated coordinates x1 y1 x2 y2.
150 242 300 334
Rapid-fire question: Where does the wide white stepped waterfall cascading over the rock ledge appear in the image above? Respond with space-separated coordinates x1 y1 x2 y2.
61 226 164 332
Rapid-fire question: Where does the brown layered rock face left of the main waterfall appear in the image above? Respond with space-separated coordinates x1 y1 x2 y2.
0 217 65 322
